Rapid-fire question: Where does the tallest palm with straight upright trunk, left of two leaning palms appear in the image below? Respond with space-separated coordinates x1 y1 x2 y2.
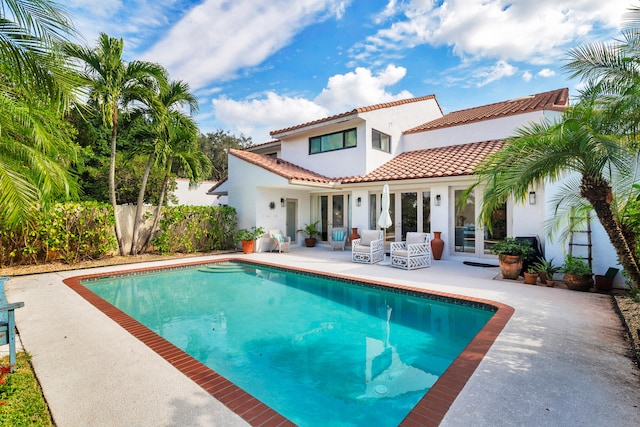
64 33 164 255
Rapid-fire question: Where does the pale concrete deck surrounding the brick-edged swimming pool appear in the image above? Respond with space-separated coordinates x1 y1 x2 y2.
5 247 640 427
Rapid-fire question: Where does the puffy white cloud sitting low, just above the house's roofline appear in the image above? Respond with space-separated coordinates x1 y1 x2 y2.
212 65 413 143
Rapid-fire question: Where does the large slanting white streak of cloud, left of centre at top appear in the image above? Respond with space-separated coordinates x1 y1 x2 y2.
143 0 345 89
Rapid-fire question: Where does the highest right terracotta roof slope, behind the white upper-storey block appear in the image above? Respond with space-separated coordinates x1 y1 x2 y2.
404 88 569 134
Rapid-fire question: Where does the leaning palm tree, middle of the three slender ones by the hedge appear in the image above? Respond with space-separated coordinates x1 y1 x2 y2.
125 75 198 255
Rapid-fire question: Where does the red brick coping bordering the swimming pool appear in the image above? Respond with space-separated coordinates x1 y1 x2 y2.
63 258 515 427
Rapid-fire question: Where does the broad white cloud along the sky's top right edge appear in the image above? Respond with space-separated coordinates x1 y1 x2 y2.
352 0 629 64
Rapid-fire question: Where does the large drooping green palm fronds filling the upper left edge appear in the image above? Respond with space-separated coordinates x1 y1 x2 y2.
0 0 77 225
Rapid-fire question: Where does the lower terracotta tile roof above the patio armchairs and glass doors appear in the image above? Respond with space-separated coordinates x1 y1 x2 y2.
339 140 504 184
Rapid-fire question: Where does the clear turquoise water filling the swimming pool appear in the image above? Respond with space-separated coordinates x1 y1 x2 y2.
83 263 493 426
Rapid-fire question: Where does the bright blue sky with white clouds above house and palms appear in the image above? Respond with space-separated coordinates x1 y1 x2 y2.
64 0 639 143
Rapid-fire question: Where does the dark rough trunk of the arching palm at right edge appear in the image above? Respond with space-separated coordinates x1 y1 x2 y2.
580 175 640 289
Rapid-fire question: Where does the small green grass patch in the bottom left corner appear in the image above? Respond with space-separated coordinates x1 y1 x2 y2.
0 352 54 427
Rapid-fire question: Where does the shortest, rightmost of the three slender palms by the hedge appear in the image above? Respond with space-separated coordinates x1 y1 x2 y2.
140 116 211 253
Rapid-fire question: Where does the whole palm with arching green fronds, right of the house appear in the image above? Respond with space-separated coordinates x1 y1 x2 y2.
475 103 640 287
